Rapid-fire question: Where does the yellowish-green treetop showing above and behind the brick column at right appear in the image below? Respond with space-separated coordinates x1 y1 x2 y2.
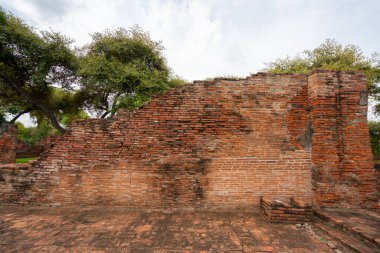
265 39 380 113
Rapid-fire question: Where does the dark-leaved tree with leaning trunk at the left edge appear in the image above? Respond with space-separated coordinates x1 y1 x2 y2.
0 9 80 133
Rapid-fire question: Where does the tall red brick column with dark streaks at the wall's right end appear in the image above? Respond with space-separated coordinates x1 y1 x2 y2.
308 70 379 207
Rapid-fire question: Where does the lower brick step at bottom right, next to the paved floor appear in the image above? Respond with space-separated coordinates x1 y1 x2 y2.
315 220 380 253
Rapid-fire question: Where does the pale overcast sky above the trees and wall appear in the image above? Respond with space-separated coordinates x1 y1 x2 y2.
0 0 380 122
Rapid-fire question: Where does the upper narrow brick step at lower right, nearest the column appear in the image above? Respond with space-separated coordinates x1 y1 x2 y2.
314 209 380 249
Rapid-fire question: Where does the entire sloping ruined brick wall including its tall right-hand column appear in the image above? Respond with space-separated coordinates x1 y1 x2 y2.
0 72 378 207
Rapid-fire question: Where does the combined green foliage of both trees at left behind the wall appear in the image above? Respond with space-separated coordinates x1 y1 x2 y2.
0 8 184 136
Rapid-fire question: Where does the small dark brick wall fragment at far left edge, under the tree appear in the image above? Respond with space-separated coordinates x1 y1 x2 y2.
0 124 17 164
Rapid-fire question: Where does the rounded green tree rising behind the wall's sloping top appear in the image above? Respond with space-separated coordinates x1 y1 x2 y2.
79 26 183 118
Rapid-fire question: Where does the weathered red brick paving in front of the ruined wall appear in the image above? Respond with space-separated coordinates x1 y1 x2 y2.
0 206 335 252
